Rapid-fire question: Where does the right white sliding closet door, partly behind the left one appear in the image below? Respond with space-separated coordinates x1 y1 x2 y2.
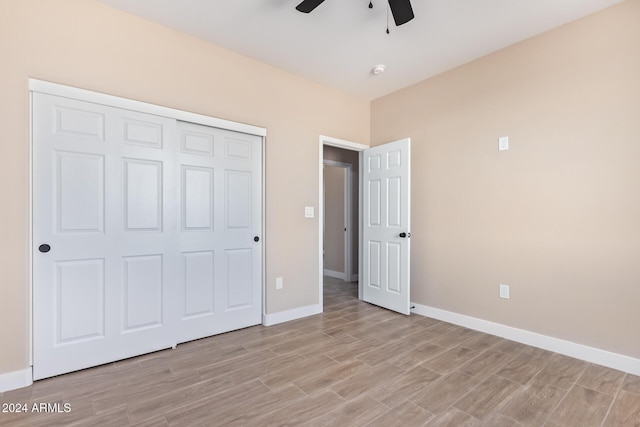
177 122 262 342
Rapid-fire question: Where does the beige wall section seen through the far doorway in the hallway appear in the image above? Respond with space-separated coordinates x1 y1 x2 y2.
323 166 346 273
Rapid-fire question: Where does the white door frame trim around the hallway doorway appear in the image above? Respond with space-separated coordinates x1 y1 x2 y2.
318 135 370 312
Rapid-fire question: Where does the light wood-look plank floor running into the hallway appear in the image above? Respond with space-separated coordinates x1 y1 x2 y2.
0 278 640 427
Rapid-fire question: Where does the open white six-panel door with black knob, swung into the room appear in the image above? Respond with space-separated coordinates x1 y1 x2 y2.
361 138 411 315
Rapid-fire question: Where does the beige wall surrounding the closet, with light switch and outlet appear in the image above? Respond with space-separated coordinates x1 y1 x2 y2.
0 0 369 374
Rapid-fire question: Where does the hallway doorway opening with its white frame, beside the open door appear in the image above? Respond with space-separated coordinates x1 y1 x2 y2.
318 136 369 307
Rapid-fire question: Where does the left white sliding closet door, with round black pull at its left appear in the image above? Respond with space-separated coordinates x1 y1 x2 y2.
33 93 177 379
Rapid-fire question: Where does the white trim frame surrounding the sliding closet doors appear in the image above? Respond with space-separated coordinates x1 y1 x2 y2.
25 78 267 376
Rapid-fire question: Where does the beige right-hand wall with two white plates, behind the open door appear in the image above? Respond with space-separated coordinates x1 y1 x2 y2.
371 0 640 358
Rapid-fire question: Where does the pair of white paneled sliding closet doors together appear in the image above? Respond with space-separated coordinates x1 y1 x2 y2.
32 93 263 379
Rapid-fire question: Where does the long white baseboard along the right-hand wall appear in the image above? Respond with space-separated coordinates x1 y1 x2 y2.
411 303 640 375
